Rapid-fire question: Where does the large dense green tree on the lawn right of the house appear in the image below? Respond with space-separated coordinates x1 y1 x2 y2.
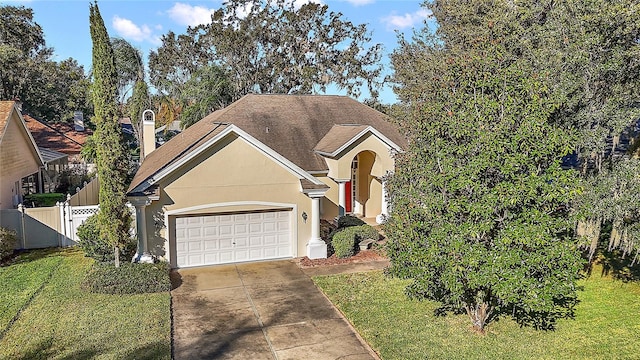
385 0 582 332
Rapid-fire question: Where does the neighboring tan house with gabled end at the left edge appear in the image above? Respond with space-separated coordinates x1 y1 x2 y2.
0 101 44 209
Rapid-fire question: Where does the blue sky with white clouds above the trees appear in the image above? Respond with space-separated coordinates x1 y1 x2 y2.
0 0 430 103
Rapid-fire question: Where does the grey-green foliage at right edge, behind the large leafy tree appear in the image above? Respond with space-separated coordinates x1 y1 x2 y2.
538 0 640 255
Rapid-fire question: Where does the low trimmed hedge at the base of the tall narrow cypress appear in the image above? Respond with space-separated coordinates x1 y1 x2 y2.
82 262 171 294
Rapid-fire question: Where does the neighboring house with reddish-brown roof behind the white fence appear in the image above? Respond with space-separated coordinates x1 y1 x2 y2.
22 114 91 192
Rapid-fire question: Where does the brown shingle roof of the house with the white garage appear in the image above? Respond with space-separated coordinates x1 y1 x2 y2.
129 95 406 191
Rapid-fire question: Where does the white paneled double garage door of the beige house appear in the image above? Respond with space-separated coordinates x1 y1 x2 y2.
176 211 293 267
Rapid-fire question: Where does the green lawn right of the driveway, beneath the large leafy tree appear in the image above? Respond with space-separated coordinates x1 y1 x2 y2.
313 271 640 360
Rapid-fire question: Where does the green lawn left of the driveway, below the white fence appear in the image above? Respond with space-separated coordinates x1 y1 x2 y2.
0 249 171 359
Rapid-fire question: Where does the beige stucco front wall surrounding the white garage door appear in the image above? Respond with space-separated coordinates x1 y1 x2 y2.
147 135 311 264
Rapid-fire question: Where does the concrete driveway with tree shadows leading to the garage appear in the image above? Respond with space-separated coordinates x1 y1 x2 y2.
171 260 377 360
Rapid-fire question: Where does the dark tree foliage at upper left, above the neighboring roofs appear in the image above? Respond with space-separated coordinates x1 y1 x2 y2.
0 5 92 122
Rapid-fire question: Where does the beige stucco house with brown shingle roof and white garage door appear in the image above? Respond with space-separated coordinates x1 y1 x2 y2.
128 95 406 267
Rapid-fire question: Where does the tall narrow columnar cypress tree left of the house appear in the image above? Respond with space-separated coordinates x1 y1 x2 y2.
89 2 131 267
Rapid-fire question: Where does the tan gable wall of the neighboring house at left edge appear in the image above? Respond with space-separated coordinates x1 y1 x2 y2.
0 111 40 209
